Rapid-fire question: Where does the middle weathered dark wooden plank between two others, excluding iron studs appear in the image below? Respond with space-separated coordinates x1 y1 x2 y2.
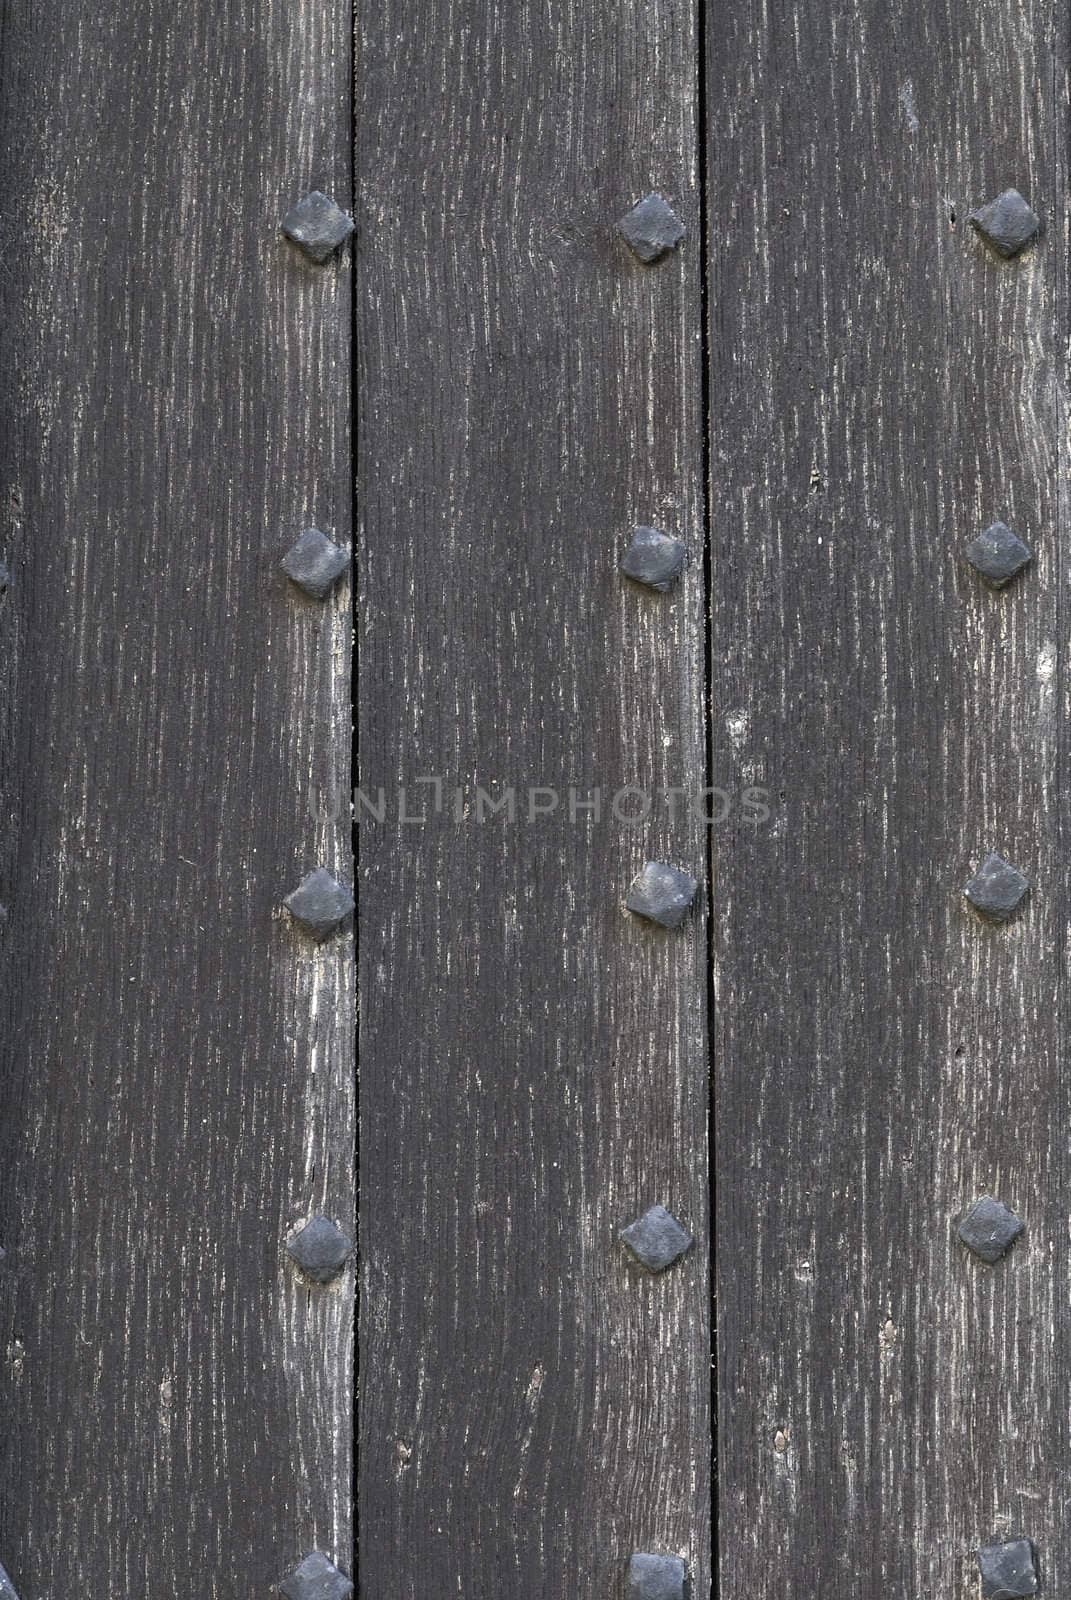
357 0 709 1600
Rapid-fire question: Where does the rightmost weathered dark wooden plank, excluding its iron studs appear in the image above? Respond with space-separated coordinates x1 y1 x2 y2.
706 0 1071 1600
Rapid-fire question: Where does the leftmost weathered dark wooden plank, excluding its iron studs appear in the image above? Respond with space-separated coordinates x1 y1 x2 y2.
0 0 354 1600
